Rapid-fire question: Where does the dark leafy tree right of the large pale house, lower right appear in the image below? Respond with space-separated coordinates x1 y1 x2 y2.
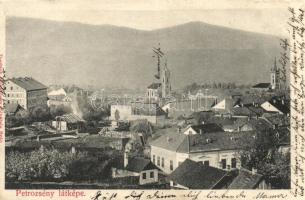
239 129 290 189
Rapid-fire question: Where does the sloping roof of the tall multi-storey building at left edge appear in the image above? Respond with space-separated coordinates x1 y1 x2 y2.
9 77 47 91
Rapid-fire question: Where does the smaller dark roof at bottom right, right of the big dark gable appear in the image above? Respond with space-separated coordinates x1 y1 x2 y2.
228 168 263 189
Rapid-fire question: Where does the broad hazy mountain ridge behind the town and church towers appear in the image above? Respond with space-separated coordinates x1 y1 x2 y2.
6 17 280 88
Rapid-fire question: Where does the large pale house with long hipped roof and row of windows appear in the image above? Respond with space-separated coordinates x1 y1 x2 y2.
150 128 255 174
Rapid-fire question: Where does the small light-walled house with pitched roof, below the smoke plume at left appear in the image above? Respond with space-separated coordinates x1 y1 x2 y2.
52 113 85 131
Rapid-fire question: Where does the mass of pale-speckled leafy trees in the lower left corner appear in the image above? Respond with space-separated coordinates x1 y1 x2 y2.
5 147 87 181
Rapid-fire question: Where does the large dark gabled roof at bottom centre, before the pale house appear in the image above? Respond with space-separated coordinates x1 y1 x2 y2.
168 159 227 189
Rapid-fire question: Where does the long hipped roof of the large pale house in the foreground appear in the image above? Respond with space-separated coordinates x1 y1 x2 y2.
150 129 255 153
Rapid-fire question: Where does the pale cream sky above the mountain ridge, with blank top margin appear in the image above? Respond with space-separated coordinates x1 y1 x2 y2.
3 0 291 36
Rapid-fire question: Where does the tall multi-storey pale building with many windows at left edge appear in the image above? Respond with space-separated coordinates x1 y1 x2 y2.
5 77 48 110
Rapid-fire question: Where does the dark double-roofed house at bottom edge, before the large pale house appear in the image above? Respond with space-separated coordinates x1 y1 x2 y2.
168 159 270 189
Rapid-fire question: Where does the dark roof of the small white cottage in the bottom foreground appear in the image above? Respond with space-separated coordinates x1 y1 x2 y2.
126 157 158 173
